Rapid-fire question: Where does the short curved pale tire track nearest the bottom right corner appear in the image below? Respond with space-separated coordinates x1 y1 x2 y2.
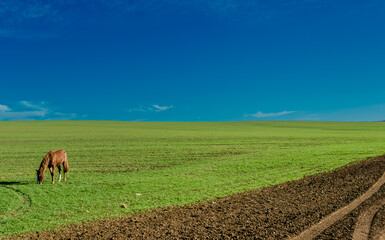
352 199 385 240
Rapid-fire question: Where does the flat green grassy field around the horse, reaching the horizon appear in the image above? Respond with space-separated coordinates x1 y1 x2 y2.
0 121 385 237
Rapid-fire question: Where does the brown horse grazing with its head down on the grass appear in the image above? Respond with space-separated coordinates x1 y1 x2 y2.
36 150 70 184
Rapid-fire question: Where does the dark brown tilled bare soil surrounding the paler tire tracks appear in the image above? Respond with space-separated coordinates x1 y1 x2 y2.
12 156 385 239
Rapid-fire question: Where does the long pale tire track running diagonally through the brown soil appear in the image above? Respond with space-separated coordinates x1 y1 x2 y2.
291 173 385 240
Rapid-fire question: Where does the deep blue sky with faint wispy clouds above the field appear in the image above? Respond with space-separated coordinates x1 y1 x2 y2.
0 0 385 121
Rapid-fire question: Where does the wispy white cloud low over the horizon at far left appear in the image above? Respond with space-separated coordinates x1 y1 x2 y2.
0 101 78 121
